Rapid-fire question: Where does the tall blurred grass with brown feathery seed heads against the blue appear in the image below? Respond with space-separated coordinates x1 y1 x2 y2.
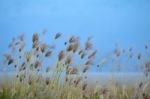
0 32 150 99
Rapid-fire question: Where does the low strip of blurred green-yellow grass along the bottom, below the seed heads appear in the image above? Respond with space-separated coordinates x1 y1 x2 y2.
0 76 150 99
